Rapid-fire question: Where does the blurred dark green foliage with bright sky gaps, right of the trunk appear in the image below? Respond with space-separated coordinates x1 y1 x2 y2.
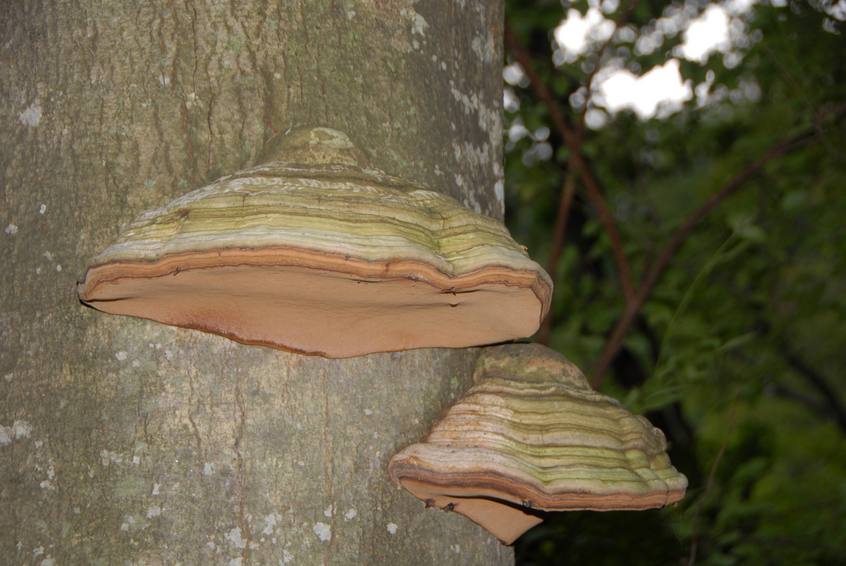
504 0 846 565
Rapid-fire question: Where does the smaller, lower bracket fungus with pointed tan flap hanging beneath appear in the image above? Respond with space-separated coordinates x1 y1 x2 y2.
388 344 687 544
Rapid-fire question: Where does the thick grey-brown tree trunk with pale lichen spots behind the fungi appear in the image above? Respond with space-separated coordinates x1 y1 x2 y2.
0 0 513 565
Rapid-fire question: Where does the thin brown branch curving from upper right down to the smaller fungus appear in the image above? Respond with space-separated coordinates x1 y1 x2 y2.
591 128 819 388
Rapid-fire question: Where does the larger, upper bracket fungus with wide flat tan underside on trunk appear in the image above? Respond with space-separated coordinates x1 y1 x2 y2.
79 128 552 357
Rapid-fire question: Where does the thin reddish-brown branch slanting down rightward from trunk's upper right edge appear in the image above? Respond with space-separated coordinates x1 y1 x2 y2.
505 21 635 303
